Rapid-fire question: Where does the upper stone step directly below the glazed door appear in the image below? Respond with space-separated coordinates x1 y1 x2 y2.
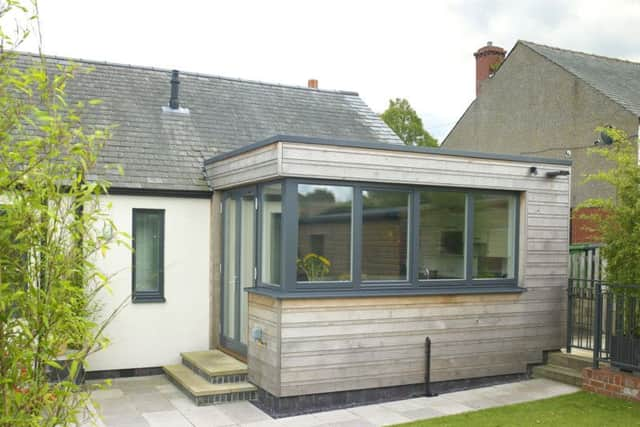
180 350 247 384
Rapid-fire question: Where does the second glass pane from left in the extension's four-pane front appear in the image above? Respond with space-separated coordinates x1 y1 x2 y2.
361 190 410 281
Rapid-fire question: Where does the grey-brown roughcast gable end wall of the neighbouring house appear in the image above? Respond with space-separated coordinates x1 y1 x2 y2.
444 44 638 207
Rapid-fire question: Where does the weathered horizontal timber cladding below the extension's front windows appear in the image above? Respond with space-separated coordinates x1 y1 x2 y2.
254 294 565 396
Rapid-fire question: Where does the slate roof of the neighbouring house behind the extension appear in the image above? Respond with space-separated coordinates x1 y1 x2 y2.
518 40 640 117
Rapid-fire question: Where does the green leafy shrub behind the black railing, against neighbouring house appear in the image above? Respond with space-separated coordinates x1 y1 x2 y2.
576 127 640 285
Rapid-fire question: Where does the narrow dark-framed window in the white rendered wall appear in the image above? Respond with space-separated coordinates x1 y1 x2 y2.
132 209 165 302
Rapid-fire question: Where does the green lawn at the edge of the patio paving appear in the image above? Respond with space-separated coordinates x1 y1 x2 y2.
398 391 640 427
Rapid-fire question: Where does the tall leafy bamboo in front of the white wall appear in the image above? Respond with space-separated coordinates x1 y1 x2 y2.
0 1 121 427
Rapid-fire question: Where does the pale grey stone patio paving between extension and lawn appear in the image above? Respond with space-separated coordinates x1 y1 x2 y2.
77 375 579 427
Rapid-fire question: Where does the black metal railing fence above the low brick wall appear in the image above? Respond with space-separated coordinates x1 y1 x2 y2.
567 278 640 371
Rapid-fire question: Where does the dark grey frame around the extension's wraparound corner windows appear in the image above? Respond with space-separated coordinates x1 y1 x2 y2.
248 178 523 297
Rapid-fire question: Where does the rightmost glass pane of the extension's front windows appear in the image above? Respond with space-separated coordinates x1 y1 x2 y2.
472 193 516 279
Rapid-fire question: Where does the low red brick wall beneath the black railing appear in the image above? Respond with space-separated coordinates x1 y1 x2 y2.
582 368 640 402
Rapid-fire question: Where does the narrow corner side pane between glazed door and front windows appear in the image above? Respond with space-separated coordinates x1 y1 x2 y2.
260 183 282 285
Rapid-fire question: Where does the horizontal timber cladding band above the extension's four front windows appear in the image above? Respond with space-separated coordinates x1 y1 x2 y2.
280 143 570 193
